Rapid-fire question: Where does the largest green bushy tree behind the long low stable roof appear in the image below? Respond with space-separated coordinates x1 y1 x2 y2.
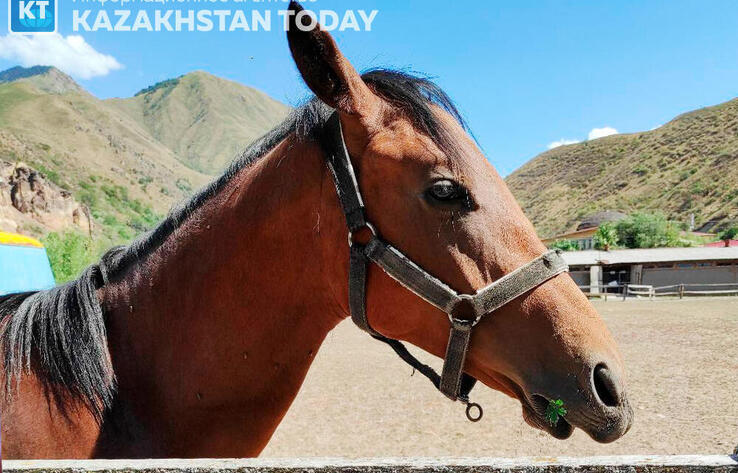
615 212 680 248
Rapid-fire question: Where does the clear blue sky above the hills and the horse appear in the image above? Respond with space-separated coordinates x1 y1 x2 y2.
0 0 738 175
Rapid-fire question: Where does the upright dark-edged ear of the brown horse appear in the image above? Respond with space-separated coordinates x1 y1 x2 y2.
287 0 379 116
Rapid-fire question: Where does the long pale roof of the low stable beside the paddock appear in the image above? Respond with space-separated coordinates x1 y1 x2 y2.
563 246 738 266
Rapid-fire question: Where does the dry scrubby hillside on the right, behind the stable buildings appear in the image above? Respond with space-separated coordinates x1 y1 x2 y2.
506 99 738 237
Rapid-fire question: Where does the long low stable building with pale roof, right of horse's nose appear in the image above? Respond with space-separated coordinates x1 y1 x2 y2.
563 246 738 292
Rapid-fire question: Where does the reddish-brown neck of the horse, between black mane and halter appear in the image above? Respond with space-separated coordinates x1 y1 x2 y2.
98 134 342 456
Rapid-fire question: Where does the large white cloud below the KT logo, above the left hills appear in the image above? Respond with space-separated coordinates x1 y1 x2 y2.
0 33 123 79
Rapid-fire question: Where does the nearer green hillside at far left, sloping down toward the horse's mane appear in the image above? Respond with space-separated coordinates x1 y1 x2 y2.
0 67 209 240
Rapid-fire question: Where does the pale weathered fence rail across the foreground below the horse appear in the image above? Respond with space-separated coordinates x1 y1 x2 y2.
3 455 738 473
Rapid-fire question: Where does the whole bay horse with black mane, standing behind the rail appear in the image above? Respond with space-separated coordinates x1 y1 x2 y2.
0 2 632 459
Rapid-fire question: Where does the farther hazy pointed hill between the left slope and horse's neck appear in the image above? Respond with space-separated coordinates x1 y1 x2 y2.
107 71 289 174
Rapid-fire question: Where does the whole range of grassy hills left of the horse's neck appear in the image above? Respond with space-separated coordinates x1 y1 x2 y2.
0 66 289 243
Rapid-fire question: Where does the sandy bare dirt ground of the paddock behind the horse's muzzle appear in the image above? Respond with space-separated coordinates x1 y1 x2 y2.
262 298 738 457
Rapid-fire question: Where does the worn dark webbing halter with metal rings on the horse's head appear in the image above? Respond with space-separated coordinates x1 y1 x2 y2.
322 111 569 422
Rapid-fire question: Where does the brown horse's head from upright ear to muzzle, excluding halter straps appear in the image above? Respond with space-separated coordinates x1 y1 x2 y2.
288 2 632 442
